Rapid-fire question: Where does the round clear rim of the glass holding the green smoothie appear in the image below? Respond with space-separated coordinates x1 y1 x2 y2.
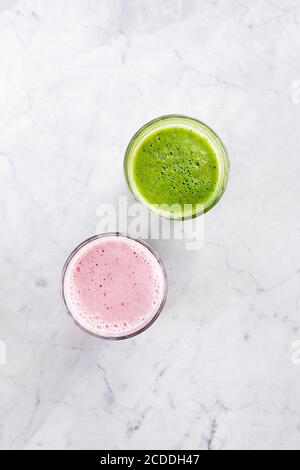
123 114 230 221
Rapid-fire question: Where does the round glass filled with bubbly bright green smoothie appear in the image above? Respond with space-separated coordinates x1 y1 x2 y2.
124 115 230 220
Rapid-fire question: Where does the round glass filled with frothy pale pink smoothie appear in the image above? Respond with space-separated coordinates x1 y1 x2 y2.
62 233 167 340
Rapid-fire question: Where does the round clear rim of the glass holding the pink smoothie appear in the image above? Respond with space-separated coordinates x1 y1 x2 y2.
60 232 168 341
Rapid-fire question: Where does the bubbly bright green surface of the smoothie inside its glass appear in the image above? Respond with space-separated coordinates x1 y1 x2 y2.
132 126 220 218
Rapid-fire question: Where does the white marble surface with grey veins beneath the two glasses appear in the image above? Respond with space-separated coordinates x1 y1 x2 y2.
0 0 300 449
